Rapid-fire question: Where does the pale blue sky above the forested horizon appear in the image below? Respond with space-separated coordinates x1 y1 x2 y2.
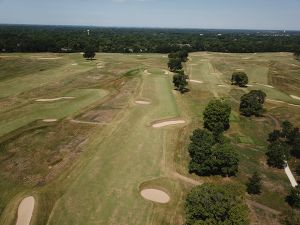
0 0 300 30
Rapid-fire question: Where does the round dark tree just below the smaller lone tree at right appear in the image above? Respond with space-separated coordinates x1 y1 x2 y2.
240 90 266 117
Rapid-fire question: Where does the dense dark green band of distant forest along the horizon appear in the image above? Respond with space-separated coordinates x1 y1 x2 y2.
0 25 300 53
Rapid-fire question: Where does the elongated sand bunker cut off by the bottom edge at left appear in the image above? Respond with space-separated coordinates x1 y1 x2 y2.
16 196 34 225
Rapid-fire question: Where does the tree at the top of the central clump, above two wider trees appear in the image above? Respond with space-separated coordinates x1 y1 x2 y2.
203 99 231 137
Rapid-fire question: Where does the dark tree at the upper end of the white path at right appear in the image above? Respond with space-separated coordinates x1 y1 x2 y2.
266 141 290 169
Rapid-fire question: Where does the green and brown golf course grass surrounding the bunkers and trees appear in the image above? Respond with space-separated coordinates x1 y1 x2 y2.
0 52 300 225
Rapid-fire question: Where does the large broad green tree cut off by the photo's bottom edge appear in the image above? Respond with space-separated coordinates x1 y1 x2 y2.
185 183 249 225
